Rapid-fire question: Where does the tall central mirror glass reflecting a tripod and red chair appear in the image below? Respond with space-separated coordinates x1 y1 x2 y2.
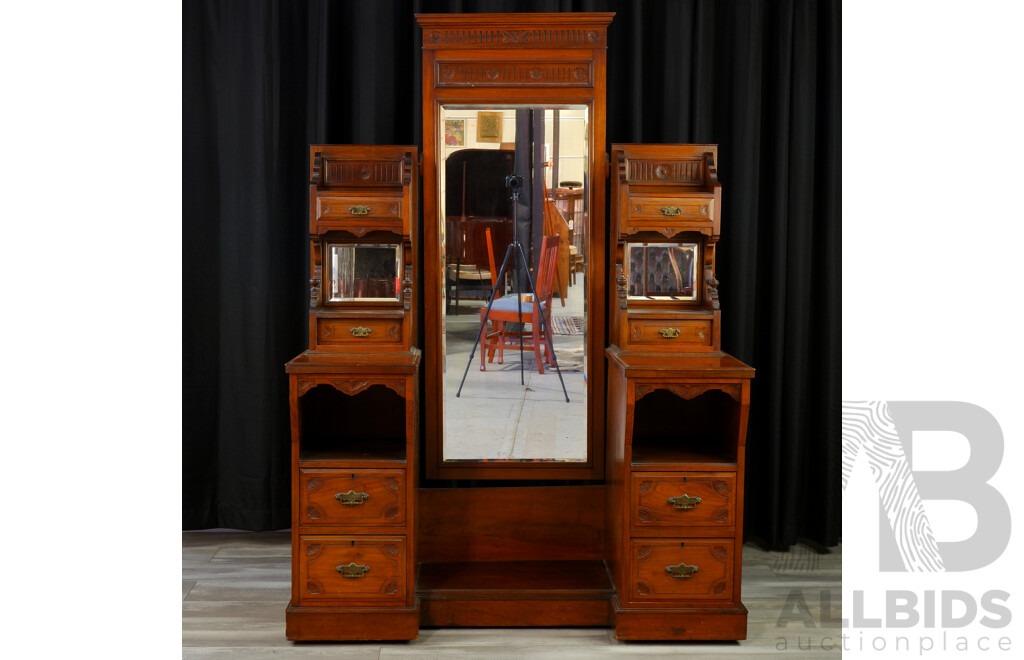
437 105 589 461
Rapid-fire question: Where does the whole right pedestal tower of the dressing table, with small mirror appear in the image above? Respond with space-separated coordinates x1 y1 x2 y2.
606 144 754 640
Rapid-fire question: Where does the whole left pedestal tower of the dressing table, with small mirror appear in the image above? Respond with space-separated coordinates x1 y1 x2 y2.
286 145 421 641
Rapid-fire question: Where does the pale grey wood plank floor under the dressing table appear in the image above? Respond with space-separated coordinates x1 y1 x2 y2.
181 531 843 660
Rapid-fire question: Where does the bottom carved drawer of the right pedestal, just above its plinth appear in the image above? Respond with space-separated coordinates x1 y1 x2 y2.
630 538 736 602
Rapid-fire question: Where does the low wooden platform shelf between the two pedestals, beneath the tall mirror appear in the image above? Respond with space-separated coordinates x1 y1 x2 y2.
417 561 613 627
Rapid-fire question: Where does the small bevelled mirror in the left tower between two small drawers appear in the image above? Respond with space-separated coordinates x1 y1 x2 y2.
327 244 401 303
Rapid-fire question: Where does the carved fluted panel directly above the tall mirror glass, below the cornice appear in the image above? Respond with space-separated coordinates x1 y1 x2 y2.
434 59 594 87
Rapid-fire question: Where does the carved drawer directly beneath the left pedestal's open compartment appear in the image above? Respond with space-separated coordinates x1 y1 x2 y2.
299 470 407 526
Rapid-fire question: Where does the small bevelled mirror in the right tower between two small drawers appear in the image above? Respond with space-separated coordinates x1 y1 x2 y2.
626 243 697 301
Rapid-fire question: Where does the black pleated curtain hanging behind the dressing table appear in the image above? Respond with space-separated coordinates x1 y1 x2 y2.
182 0 842 548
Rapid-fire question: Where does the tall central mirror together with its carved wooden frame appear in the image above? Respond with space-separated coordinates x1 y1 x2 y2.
417 13 612 480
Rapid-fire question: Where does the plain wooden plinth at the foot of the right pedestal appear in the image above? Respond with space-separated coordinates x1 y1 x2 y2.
611 599 746 641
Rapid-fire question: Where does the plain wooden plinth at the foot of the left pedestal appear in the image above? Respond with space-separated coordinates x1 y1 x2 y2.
285 603 420 642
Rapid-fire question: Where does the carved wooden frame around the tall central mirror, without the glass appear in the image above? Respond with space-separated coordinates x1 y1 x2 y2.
416 13 614 480
